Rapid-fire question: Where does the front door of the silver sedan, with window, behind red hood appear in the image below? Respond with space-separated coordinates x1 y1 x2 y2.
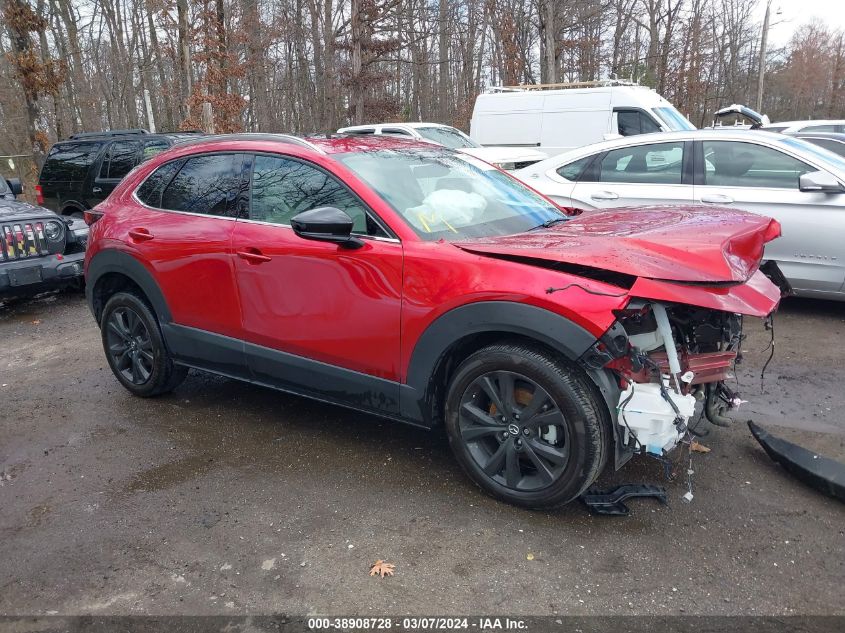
695 140 845 293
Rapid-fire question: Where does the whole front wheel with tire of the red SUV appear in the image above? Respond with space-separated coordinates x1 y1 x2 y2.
446 344 609 508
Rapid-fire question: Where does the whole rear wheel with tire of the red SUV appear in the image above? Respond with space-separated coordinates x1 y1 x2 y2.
100 292 188 397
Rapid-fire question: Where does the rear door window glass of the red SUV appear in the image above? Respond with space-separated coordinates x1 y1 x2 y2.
161 154 243 217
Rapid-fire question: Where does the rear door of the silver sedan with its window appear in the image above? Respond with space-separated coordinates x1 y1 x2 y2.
571 141 693 209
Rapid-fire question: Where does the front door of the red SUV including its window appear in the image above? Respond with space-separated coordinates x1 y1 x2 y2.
232 154 402 413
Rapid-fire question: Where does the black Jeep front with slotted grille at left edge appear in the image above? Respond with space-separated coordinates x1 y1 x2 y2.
0 173 88 298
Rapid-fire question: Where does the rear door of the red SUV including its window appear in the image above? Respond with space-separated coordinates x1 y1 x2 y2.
129 152 245 360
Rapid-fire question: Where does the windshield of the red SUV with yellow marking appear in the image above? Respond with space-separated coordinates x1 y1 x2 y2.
337 148 567 241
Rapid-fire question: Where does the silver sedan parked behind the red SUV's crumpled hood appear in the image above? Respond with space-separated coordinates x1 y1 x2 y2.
513 129 845 301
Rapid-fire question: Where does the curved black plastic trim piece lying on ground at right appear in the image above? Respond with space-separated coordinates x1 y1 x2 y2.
748 420 845 501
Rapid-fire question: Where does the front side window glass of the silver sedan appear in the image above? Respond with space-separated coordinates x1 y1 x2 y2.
702 141 815 189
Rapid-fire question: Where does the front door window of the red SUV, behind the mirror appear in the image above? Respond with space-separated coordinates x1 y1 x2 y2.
249 155 386 237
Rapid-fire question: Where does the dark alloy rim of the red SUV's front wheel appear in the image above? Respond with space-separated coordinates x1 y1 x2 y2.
458 371 570 492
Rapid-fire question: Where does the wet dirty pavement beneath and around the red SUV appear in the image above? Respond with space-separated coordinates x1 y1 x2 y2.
0 294 845 615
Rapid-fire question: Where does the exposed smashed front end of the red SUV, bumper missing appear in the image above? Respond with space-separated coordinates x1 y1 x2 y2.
581 279 779 468
